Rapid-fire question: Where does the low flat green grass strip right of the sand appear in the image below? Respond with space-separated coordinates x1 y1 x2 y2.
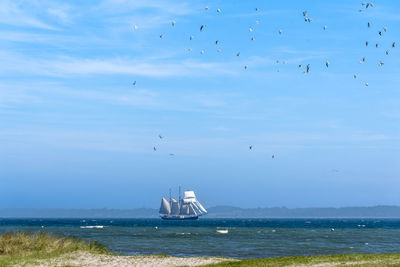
207 253 400 267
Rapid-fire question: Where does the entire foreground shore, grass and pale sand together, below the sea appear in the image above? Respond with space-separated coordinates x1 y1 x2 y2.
0 232 400 267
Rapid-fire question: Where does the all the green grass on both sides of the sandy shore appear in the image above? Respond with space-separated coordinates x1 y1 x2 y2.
0 233 400 267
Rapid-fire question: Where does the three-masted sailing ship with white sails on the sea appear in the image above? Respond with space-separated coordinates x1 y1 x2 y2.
160 188 207 220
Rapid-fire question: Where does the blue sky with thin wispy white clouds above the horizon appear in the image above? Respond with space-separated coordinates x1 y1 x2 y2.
0 0 400 209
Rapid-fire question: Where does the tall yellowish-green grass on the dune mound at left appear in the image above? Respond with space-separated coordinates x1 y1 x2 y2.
0 232 109 266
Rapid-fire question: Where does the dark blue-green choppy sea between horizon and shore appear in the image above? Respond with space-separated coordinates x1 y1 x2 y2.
0 218 400 259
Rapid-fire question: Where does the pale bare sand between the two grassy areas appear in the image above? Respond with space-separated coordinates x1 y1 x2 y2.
18 252 231 267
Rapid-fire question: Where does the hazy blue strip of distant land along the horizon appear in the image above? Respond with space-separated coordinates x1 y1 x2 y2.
0 206 400 219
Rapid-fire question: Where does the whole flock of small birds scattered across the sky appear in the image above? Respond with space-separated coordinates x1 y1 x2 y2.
133 2 396 159
